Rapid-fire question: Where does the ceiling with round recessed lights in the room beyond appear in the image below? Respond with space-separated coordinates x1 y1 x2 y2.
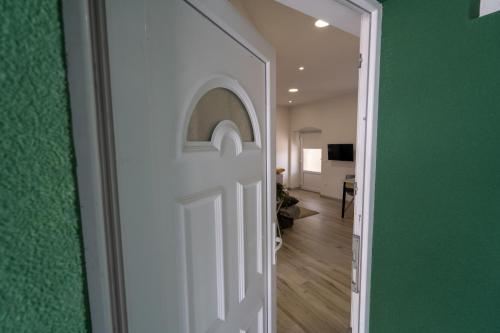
229 0 359 106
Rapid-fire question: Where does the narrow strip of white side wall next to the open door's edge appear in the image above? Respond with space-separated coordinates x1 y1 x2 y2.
276 106 290 185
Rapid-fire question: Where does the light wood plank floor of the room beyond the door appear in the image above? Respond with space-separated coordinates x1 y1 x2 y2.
277 190 353 333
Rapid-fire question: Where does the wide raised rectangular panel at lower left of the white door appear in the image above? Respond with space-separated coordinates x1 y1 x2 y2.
181 191 226 333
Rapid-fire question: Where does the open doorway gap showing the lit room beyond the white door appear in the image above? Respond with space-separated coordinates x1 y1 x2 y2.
230 0 361 333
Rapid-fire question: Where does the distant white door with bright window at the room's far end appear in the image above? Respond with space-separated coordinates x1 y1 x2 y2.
300 132 322 192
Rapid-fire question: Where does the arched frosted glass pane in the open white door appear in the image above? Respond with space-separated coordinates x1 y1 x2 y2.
187 88 254 142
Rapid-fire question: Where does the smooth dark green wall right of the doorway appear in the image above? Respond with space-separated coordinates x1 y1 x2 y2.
370 0 500 333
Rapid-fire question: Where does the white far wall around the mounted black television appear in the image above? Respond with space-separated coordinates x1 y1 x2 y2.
288 92 357 199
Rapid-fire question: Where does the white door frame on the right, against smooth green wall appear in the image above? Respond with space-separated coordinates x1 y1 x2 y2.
275 0 382 333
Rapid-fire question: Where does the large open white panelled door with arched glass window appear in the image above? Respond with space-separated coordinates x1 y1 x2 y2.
107 0 272 333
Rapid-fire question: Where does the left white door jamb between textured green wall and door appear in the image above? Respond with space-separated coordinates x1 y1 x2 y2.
63 0 127 332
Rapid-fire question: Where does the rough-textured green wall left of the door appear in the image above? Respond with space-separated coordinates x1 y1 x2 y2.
0 0 90 333
